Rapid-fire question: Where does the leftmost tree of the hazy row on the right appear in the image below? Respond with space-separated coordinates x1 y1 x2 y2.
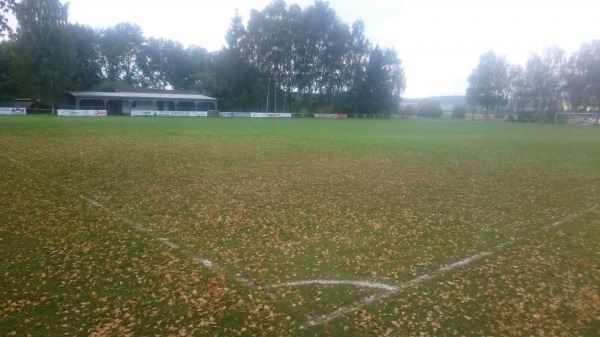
467 51 508 116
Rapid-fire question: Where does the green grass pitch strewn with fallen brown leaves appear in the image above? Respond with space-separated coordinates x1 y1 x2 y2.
0 116 600 336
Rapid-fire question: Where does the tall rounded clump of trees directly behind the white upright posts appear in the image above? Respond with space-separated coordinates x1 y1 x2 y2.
244 0 405 112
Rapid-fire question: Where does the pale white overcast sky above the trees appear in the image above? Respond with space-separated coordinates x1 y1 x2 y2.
63 0 600 97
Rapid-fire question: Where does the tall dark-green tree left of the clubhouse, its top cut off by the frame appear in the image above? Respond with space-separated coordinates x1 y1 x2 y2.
13 0 76 108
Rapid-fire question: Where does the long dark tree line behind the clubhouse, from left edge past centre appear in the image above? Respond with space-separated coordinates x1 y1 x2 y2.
0 0 406 113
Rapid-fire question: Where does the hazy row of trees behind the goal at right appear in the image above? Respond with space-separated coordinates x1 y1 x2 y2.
466 44 600 122
